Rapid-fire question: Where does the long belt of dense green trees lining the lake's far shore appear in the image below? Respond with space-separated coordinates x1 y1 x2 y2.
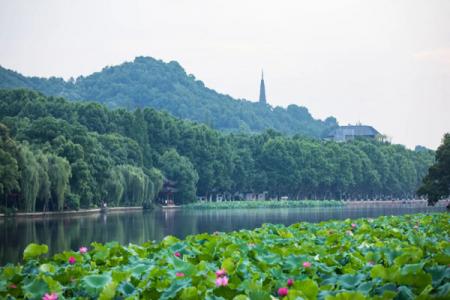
0 90 434 211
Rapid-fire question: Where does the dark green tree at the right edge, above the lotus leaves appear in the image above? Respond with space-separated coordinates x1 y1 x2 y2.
418 133 450 205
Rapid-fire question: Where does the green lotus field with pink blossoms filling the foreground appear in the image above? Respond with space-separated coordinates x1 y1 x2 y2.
0 213 450 300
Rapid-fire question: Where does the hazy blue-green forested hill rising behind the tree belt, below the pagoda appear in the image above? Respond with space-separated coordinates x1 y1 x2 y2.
0 57 337 137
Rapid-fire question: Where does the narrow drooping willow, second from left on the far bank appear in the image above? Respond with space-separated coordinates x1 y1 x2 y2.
48 154 71 211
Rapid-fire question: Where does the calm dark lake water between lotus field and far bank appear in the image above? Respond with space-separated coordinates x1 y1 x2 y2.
0 207 445 265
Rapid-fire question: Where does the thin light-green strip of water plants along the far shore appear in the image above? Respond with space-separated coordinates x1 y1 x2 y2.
182 200 344 209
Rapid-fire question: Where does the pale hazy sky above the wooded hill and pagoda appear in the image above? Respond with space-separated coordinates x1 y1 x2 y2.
0 0 450 148
